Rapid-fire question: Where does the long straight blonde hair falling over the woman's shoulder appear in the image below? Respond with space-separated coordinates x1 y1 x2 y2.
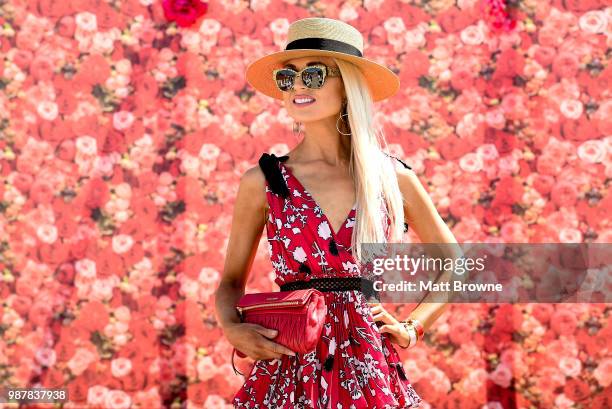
334 59 404 266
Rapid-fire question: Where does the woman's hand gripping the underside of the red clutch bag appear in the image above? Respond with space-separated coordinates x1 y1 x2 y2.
223 322 295 360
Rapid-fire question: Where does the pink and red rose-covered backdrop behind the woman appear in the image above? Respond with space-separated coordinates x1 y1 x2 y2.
0 0 612 409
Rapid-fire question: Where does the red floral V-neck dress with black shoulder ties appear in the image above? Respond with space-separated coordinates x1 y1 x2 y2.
232 154 421 409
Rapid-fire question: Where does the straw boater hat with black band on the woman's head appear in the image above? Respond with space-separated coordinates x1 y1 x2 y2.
246 17 400 101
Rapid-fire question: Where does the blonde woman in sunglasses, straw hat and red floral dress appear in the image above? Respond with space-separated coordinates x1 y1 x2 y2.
216 18 454 409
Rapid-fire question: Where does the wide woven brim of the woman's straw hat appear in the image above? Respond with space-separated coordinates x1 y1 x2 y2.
246 49 400 102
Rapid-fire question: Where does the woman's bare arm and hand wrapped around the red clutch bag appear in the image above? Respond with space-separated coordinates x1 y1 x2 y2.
215 166 293 359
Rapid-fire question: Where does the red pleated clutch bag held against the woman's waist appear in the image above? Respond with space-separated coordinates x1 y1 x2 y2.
234 288 327 364
